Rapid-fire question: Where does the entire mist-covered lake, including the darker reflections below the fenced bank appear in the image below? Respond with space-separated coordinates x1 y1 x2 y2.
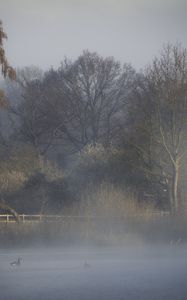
0 216 187 300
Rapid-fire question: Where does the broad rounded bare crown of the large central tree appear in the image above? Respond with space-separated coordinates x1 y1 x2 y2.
44 51 135 151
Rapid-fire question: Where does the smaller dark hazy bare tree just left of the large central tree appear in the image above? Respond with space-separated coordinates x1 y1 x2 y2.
10 74 53 156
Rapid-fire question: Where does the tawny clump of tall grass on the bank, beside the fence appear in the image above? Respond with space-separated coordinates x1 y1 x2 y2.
74 182 154 218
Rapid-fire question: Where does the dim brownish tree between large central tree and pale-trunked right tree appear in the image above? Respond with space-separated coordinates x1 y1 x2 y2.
120 74 169 208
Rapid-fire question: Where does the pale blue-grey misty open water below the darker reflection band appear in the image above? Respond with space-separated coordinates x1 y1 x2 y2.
0 245 187 300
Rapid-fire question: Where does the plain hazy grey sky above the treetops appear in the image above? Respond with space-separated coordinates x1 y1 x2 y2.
0 0 187 69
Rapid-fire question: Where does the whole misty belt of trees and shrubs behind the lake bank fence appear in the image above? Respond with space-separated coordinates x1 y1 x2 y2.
0 44 187 215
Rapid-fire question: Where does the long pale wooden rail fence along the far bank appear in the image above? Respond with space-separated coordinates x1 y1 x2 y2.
0 211 170 223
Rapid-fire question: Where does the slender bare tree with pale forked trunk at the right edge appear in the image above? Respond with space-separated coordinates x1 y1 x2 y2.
147 45 187 212
